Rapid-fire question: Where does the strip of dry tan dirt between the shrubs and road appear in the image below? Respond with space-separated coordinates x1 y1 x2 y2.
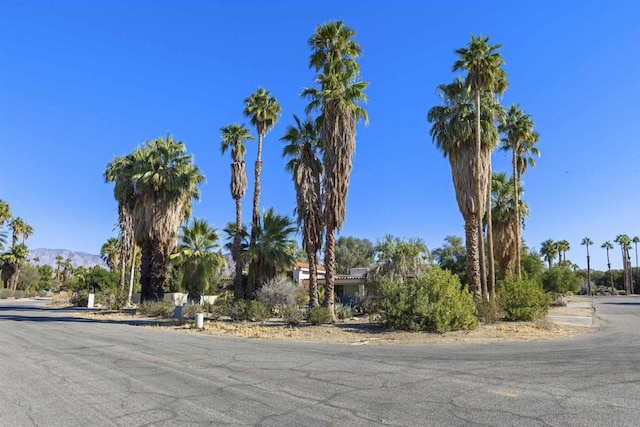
81 308 597 345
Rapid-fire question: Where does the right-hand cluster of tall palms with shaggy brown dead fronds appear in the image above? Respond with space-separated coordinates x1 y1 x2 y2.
427 35 539 299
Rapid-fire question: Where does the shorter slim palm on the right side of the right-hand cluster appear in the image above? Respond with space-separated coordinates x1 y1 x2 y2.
499 105 540 278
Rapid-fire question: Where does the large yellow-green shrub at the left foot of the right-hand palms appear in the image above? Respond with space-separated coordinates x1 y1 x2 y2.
379 266 478 333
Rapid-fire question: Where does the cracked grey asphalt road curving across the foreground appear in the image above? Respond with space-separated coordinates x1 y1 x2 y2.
0 297 640 427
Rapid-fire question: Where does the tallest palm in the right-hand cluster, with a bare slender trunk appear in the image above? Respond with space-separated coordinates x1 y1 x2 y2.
453 35 507 300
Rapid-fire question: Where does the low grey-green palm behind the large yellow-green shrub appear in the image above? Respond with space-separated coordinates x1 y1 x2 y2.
371 234 431 281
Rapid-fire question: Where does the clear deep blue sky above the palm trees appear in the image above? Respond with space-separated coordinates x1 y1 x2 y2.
0 0 640 270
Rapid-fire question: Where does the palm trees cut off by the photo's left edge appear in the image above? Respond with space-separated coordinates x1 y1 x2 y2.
0 200 33 291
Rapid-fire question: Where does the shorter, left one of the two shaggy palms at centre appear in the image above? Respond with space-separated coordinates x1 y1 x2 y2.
280 115 323 308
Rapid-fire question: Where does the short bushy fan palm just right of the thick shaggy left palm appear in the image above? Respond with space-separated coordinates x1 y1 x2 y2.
171 218 225 304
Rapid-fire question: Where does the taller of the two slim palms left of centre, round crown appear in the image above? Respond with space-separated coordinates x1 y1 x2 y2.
244 87 280 251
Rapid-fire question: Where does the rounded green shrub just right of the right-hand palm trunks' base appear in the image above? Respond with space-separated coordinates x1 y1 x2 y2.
496 278 549 321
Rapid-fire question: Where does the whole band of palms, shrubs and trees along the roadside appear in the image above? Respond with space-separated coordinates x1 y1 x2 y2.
0 21 640 342
